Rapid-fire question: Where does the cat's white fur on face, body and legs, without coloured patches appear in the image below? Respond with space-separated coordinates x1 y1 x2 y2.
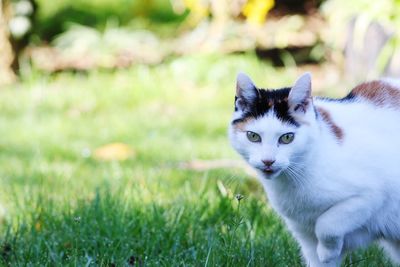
229 75 400 267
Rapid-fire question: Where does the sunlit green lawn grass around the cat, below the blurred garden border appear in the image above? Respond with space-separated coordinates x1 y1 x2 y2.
0 55 390 266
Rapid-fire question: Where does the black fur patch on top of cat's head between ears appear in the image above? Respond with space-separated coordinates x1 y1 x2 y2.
232 88 300 126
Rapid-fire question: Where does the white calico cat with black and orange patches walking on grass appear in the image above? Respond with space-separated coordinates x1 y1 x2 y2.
229 73 400 267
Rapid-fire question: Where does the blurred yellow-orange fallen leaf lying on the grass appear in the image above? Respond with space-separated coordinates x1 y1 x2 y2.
93 143 135 161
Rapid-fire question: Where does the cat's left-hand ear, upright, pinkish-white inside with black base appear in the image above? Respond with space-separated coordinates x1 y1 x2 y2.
235 72 258 111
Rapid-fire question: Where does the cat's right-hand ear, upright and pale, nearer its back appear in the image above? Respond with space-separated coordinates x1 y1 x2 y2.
288 72 311 113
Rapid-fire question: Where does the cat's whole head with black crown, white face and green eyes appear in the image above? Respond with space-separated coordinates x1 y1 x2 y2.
229 73 316 179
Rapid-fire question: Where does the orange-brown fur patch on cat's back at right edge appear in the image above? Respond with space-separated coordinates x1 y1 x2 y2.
351 81 400 108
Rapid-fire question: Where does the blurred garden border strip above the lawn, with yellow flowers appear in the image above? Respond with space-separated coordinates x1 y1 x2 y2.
0 0 400 84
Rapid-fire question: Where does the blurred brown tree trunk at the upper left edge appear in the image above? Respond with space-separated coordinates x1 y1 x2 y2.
0 0 16 86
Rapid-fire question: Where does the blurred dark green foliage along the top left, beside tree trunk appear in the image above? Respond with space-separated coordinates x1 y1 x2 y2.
34 0 184 40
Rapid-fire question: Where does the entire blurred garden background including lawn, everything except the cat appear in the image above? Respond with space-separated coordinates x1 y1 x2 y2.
0 0 400 266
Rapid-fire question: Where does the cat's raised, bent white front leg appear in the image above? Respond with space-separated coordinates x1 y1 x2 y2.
315 196 380 263
